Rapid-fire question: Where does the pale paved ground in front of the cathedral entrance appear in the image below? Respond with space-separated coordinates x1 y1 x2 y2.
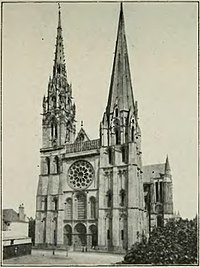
3 250 123 266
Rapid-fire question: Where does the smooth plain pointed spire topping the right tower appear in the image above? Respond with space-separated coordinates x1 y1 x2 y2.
106 3 134 113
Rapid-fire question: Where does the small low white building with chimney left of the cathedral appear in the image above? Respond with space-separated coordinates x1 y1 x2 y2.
2 204 32 259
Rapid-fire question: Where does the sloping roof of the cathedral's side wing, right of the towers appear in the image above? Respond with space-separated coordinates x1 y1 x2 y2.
142 163 165 183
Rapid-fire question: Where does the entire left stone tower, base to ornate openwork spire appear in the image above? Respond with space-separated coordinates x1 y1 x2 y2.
35 8 76 245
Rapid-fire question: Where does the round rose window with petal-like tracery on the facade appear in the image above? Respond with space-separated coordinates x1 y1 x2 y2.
68 160 94 190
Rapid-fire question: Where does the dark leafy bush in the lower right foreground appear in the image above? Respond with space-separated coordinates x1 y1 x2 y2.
123 218 198 264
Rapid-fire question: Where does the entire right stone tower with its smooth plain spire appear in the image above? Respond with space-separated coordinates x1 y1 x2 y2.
98 4 144 250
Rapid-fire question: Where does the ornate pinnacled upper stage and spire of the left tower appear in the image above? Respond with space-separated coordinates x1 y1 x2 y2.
42 7 76 148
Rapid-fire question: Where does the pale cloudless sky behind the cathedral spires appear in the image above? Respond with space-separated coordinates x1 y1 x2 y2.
2 2 198 218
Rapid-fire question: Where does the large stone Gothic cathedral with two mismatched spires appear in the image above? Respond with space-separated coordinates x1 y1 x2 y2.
35 4 173 252
